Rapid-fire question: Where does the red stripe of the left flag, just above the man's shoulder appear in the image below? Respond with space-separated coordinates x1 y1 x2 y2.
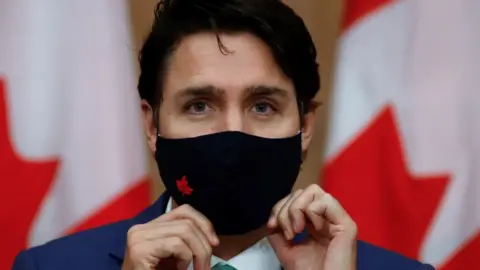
67 177 150 234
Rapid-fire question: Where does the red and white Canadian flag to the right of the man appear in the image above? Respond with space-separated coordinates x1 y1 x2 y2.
323 0 480 270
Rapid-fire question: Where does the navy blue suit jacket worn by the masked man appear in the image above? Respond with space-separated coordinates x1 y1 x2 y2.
12 194 433 270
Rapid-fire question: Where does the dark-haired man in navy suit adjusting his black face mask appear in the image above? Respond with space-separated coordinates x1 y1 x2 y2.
13 0 432 270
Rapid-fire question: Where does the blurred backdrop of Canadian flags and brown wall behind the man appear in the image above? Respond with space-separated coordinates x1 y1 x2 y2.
0 0 480 270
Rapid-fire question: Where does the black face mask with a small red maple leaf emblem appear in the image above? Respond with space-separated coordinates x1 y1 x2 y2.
155 131 302 235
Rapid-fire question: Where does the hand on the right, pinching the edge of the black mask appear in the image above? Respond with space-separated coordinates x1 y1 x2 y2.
267 185 357 270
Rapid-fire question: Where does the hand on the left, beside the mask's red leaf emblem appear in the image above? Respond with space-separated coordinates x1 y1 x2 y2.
122 205 219 270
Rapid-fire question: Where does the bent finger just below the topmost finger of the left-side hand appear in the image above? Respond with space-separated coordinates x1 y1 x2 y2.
144 219 212 269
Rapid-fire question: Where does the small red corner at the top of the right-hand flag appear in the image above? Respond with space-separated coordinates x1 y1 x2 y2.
342 0 394 31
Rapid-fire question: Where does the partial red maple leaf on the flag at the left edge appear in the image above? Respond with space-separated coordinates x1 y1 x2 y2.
0 78 58 269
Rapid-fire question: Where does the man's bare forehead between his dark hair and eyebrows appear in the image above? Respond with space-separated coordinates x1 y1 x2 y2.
163 32 294 98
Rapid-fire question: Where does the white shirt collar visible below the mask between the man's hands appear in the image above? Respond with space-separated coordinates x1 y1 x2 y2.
165 198 281 270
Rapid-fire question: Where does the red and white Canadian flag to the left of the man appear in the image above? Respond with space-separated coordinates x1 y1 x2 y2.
0 0 149 269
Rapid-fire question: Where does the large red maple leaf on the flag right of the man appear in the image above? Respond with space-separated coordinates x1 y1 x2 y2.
323 106 449 259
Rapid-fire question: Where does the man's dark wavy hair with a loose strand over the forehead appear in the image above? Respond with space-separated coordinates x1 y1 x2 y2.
138 0 320 113
